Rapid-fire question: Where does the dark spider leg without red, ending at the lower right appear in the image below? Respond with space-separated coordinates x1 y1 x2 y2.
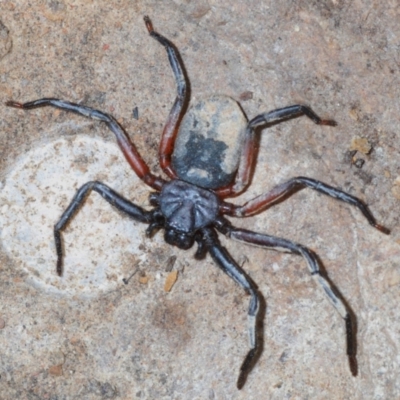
218 224 357 376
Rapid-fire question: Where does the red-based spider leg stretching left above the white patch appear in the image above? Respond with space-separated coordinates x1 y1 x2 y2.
6 98 165 190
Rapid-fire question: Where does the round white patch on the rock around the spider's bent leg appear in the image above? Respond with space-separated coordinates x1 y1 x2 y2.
0 136 153 296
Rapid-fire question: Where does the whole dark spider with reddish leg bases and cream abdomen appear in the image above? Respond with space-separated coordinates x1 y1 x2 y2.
6 16 389 389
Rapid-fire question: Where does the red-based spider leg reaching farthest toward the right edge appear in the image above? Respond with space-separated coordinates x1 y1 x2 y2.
222 176 390 234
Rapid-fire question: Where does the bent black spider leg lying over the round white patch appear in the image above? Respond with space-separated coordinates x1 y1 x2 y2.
54 181 153 276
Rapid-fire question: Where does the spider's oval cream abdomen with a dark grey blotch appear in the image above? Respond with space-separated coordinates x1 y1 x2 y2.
172 96 247 189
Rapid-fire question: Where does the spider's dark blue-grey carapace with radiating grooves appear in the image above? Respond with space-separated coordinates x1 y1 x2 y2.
160 180 219 233
